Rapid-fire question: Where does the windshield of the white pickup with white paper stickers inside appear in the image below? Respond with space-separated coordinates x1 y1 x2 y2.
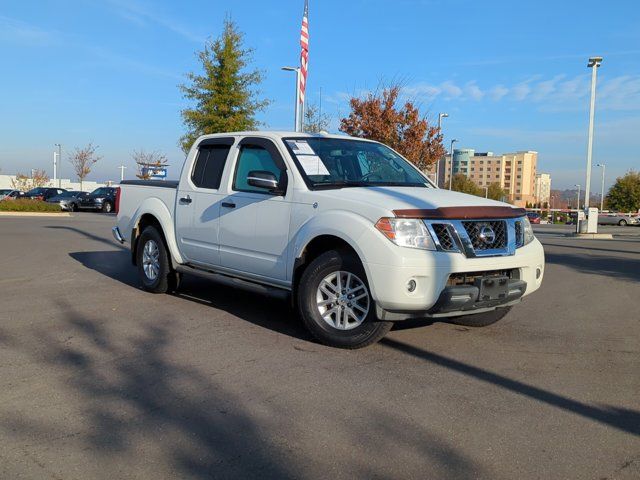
284 137 432 188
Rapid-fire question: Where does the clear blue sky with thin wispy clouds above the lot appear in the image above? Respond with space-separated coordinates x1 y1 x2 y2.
0 0 640 191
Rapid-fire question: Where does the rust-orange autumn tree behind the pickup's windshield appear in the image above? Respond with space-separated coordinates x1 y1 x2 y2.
340 85 446 170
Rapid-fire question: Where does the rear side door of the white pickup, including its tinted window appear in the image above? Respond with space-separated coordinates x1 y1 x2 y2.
175 137 235 266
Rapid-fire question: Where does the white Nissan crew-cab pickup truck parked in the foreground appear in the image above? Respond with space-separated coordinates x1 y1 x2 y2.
113 132 544 348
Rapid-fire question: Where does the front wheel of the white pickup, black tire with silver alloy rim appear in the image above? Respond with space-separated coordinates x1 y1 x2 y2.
297 250 392 349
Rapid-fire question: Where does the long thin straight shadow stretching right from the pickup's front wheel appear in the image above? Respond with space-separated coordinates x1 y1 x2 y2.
380 338 640 436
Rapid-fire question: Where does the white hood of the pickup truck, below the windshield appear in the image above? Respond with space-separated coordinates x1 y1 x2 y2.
314 187 512 211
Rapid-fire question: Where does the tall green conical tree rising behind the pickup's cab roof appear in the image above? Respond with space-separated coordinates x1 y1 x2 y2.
180 18 269 153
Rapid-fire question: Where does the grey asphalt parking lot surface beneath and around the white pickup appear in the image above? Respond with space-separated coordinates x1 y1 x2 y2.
0 213 640 479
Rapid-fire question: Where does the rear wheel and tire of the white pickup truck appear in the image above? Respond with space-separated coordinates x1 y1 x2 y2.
136 226 172 293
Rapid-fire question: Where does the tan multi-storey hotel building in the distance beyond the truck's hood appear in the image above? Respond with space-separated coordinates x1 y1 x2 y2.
427 148 538 206
